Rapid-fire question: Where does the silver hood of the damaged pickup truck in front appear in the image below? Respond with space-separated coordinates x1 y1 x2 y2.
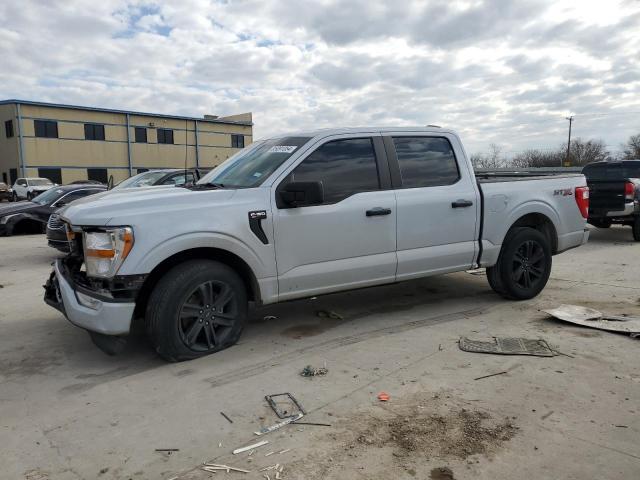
58 186 235 226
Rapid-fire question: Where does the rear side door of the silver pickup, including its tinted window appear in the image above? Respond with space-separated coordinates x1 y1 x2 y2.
385 133 479 280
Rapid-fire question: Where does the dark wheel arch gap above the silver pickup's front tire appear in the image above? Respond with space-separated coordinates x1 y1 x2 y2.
134 247 261 320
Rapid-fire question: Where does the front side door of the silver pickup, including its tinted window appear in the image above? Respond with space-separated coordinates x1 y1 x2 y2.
272 134 396 300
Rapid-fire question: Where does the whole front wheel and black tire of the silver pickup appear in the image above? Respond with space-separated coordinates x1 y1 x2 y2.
146 260 247 362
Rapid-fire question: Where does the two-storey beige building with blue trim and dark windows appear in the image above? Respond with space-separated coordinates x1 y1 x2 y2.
0 100 253 184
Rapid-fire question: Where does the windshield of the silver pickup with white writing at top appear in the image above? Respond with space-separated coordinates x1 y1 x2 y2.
198 137 311 188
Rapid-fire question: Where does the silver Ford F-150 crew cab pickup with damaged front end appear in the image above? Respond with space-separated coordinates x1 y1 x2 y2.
45 127 589 361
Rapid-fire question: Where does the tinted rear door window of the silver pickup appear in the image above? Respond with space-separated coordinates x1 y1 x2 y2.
393 137 460 188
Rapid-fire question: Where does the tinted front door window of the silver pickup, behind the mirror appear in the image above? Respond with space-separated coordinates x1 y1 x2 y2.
289 138 380 203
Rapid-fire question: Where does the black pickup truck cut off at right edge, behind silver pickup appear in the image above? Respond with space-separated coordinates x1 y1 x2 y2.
582 160 640 241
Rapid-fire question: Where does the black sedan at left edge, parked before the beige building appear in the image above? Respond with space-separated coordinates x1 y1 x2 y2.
0 185 106 235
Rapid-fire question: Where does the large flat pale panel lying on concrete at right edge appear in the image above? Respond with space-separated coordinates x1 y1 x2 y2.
543 305 640 338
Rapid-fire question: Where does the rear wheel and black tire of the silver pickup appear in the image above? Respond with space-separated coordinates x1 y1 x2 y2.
487 228 552 300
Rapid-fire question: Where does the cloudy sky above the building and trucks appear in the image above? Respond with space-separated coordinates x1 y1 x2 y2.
0 0 640 153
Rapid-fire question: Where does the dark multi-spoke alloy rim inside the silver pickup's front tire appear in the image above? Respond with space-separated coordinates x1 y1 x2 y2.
179 280 239 352
